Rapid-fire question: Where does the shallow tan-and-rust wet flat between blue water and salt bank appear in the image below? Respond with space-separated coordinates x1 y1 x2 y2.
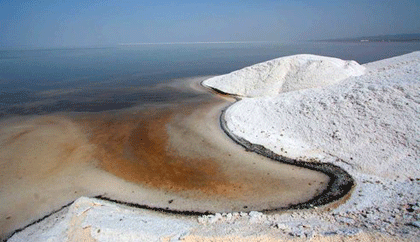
0 77 329 238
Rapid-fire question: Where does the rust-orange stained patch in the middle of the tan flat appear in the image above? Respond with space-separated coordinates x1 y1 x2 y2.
77 109 242 197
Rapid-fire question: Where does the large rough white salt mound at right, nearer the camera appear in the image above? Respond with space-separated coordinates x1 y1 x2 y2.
221 52 420 178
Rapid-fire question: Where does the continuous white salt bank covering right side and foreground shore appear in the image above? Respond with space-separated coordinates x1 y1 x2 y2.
7 52 420 241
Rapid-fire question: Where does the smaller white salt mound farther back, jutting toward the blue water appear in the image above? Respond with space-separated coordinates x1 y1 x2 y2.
203 55 365 97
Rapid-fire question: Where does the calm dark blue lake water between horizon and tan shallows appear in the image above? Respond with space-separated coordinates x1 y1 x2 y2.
0 42 420 117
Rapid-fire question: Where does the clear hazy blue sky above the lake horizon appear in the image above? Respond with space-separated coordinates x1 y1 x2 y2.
0 0 420 48
